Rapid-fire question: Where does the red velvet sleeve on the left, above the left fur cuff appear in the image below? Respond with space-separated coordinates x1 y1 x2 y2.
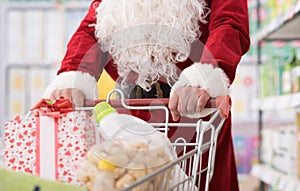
58 0 105 80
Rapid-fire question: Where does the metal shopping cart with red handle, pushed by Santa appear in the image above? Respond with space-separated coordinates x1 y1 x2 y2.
82 89 230 191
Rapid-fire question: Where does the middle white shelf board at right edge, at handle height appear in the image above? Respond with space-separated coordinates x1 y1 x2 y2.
252 92 300 111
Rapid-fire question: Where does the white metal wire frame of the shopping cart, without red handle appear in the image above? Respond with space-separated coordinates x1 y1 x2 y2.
76 89 226 191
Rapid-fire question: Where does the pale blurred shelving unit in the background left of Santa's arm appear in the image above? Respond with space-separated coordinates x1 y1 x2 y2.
0 0 90 129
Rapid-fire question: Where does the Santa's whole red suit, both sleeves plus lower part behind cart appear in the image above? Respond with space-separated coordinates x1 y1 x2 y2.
57 0 250 191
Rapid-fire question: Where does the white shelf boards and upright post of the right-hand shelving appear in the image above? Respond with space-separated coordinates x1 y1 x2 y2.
251 0 300 190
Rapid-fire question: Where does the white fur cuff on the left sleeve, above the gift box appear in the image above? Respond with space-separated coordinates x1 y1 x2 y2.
43 71 98 100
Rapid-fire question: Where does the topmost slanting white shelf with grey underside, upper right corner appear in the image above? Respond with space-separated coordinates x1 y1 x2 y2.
251 0 300 44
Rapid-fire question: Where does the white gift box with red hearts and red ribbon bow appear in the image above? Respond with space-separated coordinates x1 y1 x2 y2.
4 97 100 184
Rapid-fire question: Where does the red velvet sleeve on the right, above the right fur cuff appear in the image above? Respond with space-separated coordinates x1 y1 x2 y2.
201 0 250 83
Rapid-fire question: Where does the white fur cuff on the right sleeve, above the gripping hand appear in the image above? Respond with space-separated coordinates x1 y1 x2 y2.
171 63 229 97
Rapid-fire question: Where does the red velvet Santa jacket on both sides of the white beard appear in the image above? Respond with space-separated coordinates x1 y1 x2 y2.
58 0 250 83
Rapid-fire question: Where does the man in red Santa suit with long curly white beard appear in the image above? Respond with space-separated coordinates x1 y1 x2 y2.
44 0 250 191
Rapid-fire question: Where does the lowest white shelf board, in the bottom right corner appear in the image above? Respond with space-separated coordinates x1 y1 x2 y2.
251 164 300 190
